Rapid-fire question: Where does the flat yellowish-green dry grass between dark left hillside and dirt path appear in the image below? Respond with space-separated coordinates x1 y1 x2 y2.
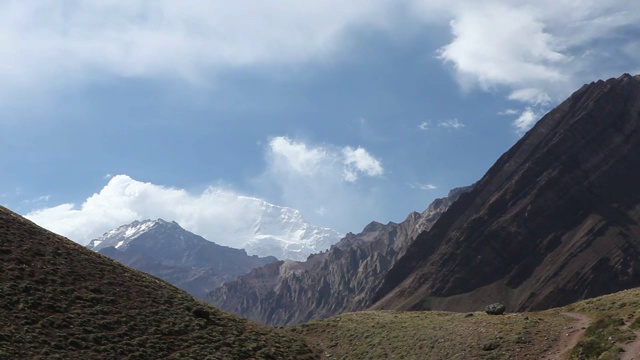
293 311 571 359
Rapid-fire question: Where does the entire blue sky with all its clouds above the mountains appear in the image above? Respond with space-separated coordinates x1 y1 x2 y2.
0 0 640 245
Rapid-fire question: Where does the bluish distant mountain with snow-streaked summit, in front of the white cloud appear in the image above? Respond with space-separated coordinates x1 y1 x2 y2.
87 219 277 298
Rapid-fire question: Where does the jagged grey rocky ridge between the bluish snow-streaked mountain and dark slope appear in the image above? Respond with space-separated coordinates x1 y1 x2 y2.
206 188 467 325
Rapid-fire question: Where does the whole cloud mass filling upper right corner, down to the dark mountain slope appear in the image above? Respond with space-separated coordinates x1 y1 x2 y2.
437 0 640 131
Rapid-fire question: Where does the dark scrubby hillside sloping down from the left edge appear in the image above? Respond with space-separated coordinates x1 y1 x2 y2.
0 207 318 359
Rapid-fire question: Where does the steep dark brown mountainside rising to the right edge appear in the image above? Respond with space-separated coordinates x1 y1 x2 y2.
373 74 640 311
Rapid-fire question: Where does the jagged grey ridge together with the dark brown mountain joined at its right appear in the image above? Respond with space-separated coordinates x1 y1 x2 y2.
207 74 640 324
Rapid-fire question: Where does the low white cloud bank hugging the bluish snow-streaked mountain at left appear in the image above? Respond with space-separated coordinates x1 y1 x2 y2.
26 175 332 248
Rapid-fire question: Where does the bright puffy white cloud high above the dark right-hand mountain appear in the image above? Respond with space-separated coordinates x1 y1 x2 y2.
439 2 569 89
